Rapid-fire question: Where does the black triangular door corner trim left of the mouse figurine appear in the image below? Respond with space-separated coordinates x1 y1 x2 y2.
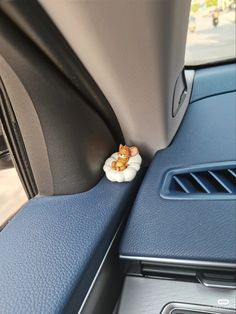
0 11 116 195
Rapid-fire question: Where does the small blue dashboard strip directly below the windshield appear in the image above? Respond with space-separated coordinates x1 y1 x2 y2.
191 64 236 102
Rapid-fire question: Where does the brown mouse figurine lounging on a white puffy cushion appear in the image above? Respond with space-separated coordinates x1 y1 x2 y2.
103 144 142 182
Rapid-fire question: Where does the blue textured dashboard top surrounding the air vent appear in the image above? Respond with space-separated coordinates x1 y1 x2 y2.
120 93 236 263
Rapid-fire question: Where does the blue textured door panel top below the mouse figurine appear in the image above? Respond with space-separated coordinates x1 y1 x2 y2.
0 178 142 314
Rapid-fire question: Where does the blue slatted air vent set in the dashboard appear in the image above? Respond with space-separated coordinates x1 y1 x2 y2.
161 162 236 199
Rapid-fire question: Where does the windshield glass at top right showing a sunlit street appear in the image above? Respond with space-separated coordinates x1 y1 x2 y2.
185 0 236 65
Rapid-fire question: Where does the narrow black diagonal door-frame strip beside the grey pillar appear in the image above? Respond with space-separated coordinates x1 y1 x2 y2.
0 0 124 144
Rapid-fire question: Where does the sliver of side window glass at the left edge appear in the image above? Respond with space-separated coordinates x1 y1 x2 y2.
0 121 27 230
